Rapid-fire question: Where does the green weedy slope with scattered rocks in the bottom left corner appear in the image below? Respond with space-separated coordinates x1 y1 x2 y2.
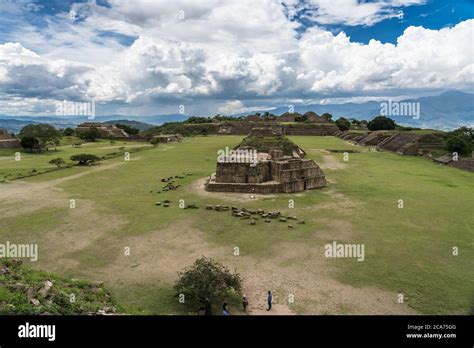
0 259 119 315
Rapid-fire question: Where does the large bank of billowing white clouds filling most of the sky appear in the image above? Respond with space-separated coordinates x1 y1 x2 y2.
0 0 474 114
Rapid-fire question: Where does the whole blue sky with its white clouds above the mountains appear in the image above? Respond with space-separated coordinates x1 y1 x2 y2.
0 0 474 116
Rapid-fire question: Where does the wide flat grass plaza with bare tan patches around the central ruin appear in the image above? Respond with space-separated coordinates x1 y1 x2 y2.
0 136 474 314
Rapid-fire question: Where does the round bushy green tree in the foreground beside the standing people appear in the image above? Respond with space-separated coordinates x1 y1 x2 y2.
174 256 242 310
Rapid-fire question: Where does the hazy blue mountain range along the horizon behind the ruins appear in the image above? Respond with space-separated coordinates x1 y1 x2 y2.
0 91 474 133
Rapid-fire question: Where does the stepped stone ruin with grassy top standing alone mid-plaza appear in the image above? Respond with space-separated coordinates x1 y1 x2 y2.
206 128 326 194
